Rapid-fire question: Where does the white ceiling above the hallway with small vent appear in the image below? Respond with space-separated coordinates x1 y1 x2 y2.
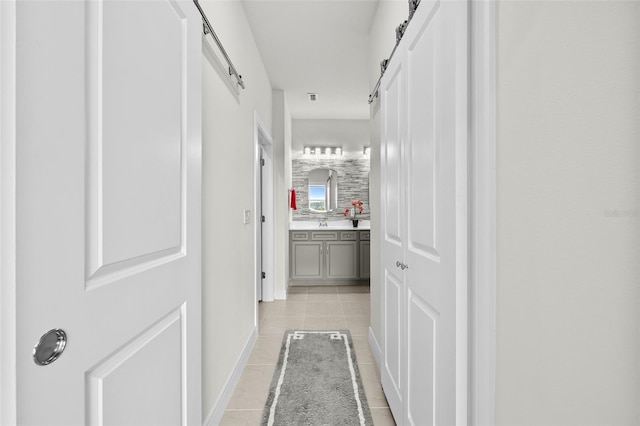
243 0 378 119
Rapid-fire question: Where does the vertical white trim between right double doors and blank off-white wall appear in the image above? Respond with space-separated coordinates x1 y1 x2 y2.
469 0 497 425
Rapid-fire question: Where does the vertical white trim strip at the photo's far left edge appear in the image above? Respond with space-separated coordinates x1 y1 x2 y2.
0 0 17 425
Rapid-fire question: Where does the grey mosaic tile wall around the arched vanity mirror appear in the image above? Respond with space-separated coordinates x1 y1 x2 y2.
291 155 370 220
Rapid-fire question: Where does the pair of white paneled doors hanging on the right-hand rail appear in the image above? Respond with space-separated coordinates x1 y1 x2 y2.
381 0 467 426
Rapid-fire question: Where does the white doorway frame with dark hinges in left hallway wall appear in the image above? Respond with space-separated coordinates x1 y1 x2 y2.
253 111 275 304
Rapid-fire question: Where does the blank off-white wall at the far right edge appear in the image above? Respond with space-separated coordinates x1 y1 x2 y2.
496 1 640 425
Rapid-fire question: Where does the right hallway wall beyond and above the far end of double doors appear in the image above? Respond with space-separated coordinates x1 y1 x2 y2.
369 0 409 358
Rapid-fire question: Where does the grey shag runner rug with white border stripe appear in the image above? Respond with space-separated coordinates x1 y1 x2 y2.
261 330 373 426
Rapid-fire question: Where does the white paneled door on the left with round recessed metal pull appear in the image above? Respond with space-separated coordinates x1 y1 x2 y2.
17 0 202 425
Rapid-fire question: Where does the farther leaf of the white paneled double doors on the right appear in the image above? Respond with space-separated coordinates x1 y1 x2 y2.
380 54 405 419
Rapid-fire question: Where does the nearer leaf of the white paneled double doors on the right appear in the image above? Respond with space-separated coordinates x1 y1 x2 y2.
404 1 466 426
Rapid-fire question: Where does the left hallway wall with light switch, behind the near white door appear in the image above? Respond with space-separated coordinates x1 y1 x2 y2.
200 0 271 419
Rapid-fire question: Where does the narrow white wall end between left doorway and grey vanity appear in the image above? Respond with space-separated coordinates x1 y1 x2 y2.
272 89 291 299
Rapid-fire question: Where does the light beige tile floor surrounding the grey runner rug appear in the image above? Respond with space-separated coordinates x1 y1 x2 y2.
220 286 395 426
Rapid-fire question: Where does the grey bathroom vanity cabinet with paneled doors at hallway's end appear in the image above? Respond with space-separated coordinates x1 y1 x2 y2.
289 228 371 285
